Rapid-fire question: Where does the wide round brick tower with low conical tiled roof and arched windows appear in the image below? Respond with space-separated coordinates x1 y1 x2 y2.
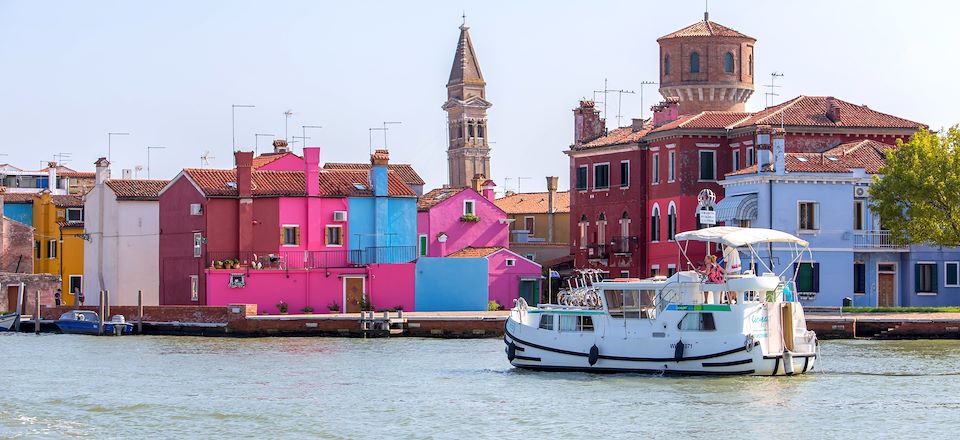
657 12 757 115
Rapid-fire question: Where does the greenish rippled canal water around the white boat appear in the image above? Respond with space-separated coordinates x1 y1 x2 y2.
0 334 960 439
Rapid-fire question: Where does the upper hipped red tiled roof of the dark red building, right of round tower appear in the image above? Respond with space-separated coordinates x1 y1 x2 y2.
736 95 926 130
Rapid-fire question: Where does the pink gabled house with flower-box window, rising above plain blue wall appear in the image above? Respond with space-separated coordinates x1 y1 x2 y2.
417 180 510 257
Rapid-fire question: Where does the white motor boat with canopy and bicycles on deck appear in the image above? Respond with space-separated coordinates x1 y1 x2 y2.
504 226 818 376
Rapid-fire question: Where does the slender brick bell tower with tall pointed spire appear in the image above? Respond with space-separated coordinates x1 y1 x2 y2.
442 25 492 188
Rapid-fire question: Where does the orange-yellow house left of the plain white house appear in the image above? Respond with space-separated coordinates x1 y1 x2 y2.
33 190 89 305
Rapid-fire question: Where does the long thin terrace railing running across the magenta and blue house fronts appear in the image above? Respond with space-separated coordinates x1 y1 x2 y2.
205 246 417 270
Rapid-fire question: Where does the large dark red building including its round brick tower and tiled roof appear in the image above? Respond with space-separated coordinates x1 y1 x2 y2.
566 17 923 277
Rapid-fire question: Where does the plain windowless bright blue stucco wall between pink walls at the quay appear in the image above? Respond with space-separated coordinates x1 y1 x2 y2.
416 257 489 312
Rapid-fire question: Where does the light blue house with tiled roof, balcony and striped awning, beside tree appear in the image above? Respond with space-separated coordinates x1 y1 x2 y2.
716 131 960 307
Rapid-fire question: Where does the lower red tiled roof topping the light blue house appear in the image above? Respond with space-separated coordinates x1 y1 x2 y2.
727 140 895 176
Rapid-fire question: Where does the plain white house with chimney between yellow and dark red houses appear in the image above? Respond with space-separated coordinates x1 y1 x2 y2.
83 158 168 305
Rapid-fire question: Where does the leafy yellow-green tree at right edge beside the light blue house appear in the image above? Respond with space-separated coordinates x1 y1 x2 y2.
870 125 960 246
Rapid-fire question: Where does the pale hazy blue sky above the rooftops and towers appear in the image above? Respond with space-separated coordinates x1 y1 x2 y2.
0 0 960 191
